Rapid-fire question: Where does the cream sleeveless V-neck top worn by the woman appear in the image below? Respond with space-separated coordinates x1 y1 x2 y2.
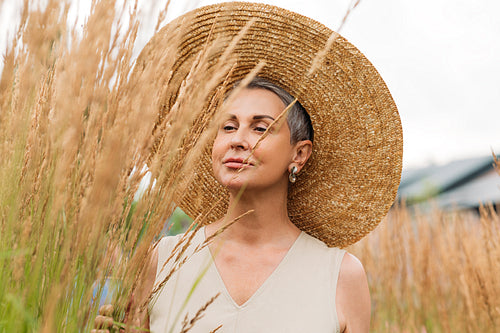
150 228 345 333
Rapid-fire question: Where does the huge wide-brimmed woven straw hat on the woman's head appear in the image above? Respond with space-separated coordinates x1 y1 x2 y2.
138 2 403 247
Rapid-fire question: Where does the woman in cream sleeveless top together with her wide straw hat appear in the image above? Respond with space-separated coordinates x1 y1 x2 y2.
94 3 402 332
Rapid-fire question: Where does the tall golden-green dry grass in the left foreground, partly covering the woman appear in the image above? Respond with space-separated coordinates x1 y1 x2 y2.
0 0 239 332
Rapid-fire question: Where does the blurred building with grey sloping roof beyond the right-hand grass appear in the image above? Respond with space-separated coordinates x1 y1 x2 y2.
398 155 500 210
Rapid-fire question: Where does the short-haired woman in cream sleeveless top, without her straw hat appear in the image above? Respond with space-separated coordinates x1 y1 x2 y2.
146 79 370 332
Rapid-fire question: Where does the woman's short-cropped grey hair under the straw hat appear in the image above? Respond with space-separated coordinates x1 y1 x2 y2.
237 76 314 144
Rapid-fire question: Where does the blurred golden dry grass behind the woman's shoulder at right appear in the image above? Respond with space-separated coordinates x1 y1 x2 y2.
351 201 500 332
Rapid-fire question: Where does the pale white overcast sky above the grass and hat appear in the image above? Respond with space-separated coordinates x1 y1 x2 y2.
0 0 500 168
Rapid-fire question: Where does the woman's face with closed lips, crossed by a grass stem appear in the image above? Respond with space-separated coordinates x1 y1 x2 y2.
212 88 295 190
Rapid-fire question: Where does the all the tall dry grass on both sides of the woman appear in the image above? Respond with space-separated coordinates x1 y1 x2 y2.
0 0 500 332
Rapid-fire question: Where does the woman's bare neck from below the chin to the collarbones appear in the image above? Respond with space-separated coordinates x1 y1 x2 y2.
207 183 300 245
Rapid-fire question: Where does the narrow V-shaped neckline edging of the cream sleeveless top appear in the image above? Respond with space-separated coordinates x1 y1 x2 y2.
202 227 304 310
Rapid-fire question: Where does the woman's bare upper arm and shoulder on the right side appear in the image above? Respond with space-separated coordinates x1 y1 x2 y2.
335 253 371 333
